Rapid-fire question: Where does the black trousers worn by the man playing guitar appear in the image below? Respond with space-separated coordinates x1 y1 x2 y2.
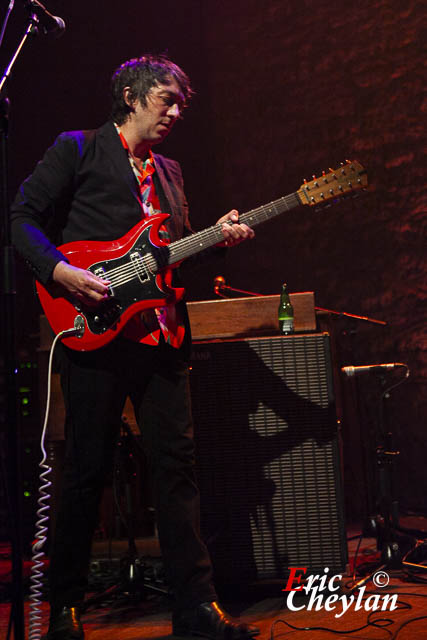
50 337 216 610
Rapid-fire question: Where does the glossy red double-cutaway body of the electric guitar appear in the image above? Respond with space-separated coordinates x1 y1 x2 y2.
36 213 184 351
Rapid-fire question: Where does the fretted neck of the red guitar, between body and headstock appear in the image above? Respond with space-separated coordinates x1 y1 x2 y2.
168 193 302 265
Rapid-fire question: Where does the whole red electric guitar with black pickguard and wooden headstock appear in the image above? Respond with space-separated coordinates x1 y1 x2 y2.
36 161 368 351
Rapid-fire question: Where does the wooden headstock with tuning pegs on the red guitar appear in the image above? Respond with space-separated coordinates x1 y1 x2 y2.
297 160 368 206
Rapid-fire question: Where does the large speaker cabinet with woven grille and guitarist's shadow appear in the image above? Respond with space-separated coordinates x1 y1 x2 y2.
190 334 347 584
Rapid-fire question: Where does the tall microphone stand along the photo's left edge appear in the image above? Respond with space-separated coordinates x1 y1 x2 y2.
0 12 45 640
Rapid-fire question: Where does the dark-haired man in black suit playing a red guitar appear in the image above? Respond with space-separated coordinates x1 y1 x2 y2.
12 55 258 640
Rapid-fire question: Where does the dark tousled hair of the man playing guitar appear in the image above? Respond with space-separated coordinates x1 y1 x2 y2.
111 53 194 125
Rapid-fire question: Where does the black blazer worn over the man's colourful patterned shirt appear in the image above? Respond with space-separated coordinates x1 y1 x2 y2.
11 122 192 284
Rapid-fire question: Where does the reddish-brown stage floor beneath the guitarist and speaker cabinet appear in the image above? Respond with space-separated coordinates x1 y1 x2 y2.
0 518 427 640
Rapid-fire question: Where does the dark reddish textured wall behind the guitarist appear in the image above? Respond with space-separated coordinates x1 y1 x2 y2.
2 0 427 511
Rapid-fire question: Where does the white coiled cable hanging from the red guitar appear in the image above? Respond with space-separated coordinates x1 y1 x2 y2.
28 326 84 640
